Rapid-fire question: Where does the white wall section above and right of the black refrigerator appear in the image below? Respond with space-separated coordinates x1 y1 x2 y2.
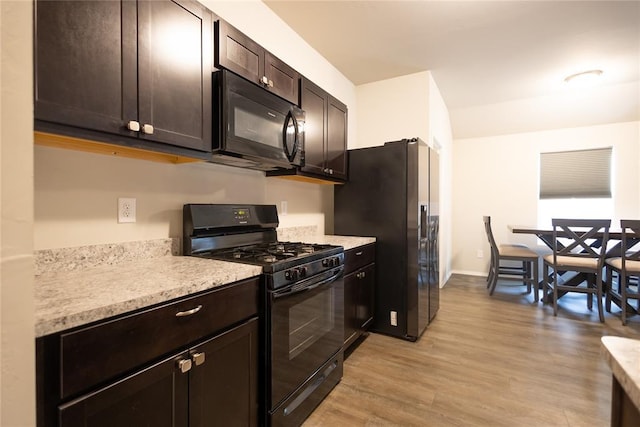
349 71 452 285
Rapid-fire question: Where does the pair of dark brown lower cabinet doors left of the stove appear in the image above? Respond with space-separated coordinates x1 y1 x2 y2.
59 318 258 427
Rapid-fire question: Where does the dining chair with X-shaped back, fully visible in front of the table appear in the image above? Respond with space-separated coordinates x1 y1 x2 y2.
543 218 611 322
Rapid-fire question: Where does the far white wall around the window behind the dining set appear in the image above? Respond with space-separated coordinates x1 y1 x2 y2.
452 122 640 275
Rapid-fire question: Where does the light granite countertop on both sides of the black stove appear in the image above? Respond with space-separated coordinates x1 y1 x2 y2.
35 235 375 337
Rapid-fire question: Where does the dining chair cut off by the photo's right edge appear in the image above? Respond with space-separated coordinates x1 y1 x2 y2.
605 219 640 325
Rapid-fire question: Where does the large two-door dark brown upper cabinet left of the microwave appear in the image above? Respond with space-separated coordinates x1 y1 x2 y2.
34 0 213 152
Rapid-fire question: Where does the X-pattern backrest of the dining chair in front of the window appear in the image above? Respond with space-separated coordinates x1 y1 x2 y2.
551 218 611 265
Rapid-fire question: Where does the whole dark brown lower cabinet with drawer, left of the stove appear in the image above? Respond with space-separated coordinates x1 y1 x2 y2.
36 277 260 427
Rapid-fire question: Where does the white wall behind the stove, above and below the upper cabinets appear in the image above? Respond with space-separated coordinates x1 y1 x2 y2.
33 0 356 249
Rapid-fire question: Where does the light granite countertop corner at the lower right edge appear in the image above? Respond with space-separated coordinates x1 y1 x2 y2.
601 336 640 409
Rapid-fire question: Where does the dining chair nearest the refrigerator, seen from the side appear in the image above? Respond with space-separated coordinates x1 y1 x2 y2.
482 216 538 302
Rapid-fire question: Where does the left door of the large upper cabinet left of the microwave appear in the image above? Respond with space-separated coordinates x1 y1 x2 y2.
34 1 138 136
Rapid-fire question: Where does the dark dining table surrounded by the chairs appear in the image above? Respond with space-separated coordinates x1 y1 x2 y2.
508 225 640 313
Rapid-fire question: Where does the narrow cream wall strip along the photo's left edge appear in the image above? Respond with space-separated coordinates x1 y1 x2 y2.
0 1 35 427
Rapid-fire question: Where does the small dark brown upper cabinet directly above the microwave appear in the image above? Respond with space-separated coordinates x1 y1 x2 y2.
214 19 300 104
